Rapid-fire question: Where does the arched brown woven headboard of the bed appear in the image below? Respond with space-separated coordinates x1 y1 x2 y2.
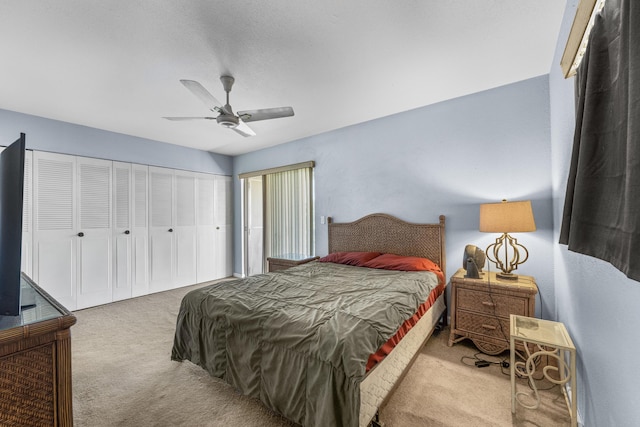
328 213 446 277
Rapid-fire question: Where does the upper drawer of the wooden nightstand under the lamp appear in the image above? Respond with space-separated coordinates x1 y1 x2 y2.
456 288 530 318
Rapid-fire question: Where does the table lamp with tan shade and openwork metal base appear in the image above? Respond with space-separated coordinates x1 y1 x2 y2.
480 200 536 280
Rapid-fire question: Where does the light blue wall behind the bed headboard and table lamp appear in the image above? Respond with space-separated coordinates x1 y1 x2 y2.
233 76 555 317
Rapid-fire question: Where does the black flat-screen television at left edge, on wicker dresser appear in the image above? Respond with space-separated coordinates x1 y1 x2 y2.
0 133 25 316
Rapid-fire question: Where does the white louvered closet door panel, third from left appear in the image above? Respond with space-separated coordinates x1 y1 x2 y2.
76 157 113 309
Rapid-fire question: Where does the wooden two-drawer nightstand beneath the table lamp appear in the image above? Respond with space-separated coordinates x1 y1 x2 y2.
449 268 538 355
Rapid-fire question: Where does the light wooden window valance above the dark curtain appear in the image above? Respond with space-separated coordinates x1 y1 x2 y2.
560 0 605 79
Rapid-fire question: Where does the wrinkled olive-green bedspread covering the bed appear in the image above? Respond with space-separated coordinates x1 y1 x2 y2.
171 262 438 427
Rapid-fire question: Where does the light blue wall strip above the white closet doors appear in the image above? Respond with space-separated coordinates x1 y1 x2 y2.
0 110 232 175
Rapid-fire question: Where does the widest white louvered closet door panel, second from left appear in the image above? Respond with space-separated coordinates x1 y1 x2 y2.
33 151 78 310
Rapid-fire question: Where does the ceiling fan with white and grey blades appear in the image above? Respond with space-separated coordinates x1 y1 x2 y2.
165 76 293 136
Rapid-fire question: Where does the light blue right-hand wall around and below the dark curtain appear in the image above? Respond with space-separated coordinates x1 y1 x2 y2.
549 0 640 426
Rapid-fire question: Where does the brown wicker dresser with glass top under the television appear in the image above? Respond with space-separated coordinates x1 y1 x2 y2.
0 276 76 427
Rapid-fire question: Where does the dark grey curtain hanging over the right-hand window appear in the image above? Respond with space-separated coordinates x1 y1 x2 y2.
560 0 640 281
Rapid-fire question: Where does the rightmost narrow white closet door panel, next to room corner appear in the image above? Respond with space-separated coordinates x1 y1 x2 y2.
213 175 233 279
